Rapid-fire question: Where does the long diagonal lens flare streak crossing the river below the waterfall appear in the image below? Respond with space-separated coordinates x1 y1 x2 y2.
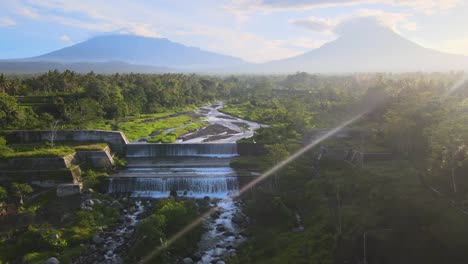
139 111 368 263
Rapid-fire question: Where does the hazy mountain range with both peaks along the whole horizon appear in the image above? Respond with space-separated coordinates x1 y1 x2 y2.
0 20 468 74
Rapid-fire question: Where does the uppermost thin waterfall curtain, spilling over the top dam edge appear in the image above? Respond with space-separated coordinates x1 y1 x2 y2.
127 143 238 158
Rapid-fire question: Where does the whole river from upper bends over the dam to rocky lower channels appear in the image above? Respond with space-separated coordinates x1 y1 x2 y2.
105 103 262 264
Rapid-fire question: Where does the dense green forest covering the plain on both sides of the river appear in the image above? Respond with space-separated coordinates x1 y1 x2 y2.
0 71 468 263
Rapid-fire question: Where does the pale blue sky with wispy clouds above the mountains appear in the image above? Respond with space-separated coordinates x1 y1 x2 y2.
0 0 468 62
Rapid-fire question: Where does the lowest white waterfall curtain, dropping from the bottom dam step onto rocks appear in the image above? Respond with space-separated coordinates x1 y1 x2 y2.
108 177 239 198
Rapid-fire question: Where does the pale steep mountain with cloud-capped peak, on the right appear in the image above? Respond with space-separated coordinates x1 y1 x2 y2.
256 20 468 73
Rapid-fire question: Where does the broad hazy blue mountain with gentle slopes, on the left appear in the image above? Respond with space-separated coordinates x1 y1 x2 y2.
22 35 246 70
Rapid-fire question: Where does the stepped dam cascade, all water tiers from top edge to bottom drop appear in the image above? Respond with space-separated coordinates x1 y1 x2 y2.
108 143 239 198
